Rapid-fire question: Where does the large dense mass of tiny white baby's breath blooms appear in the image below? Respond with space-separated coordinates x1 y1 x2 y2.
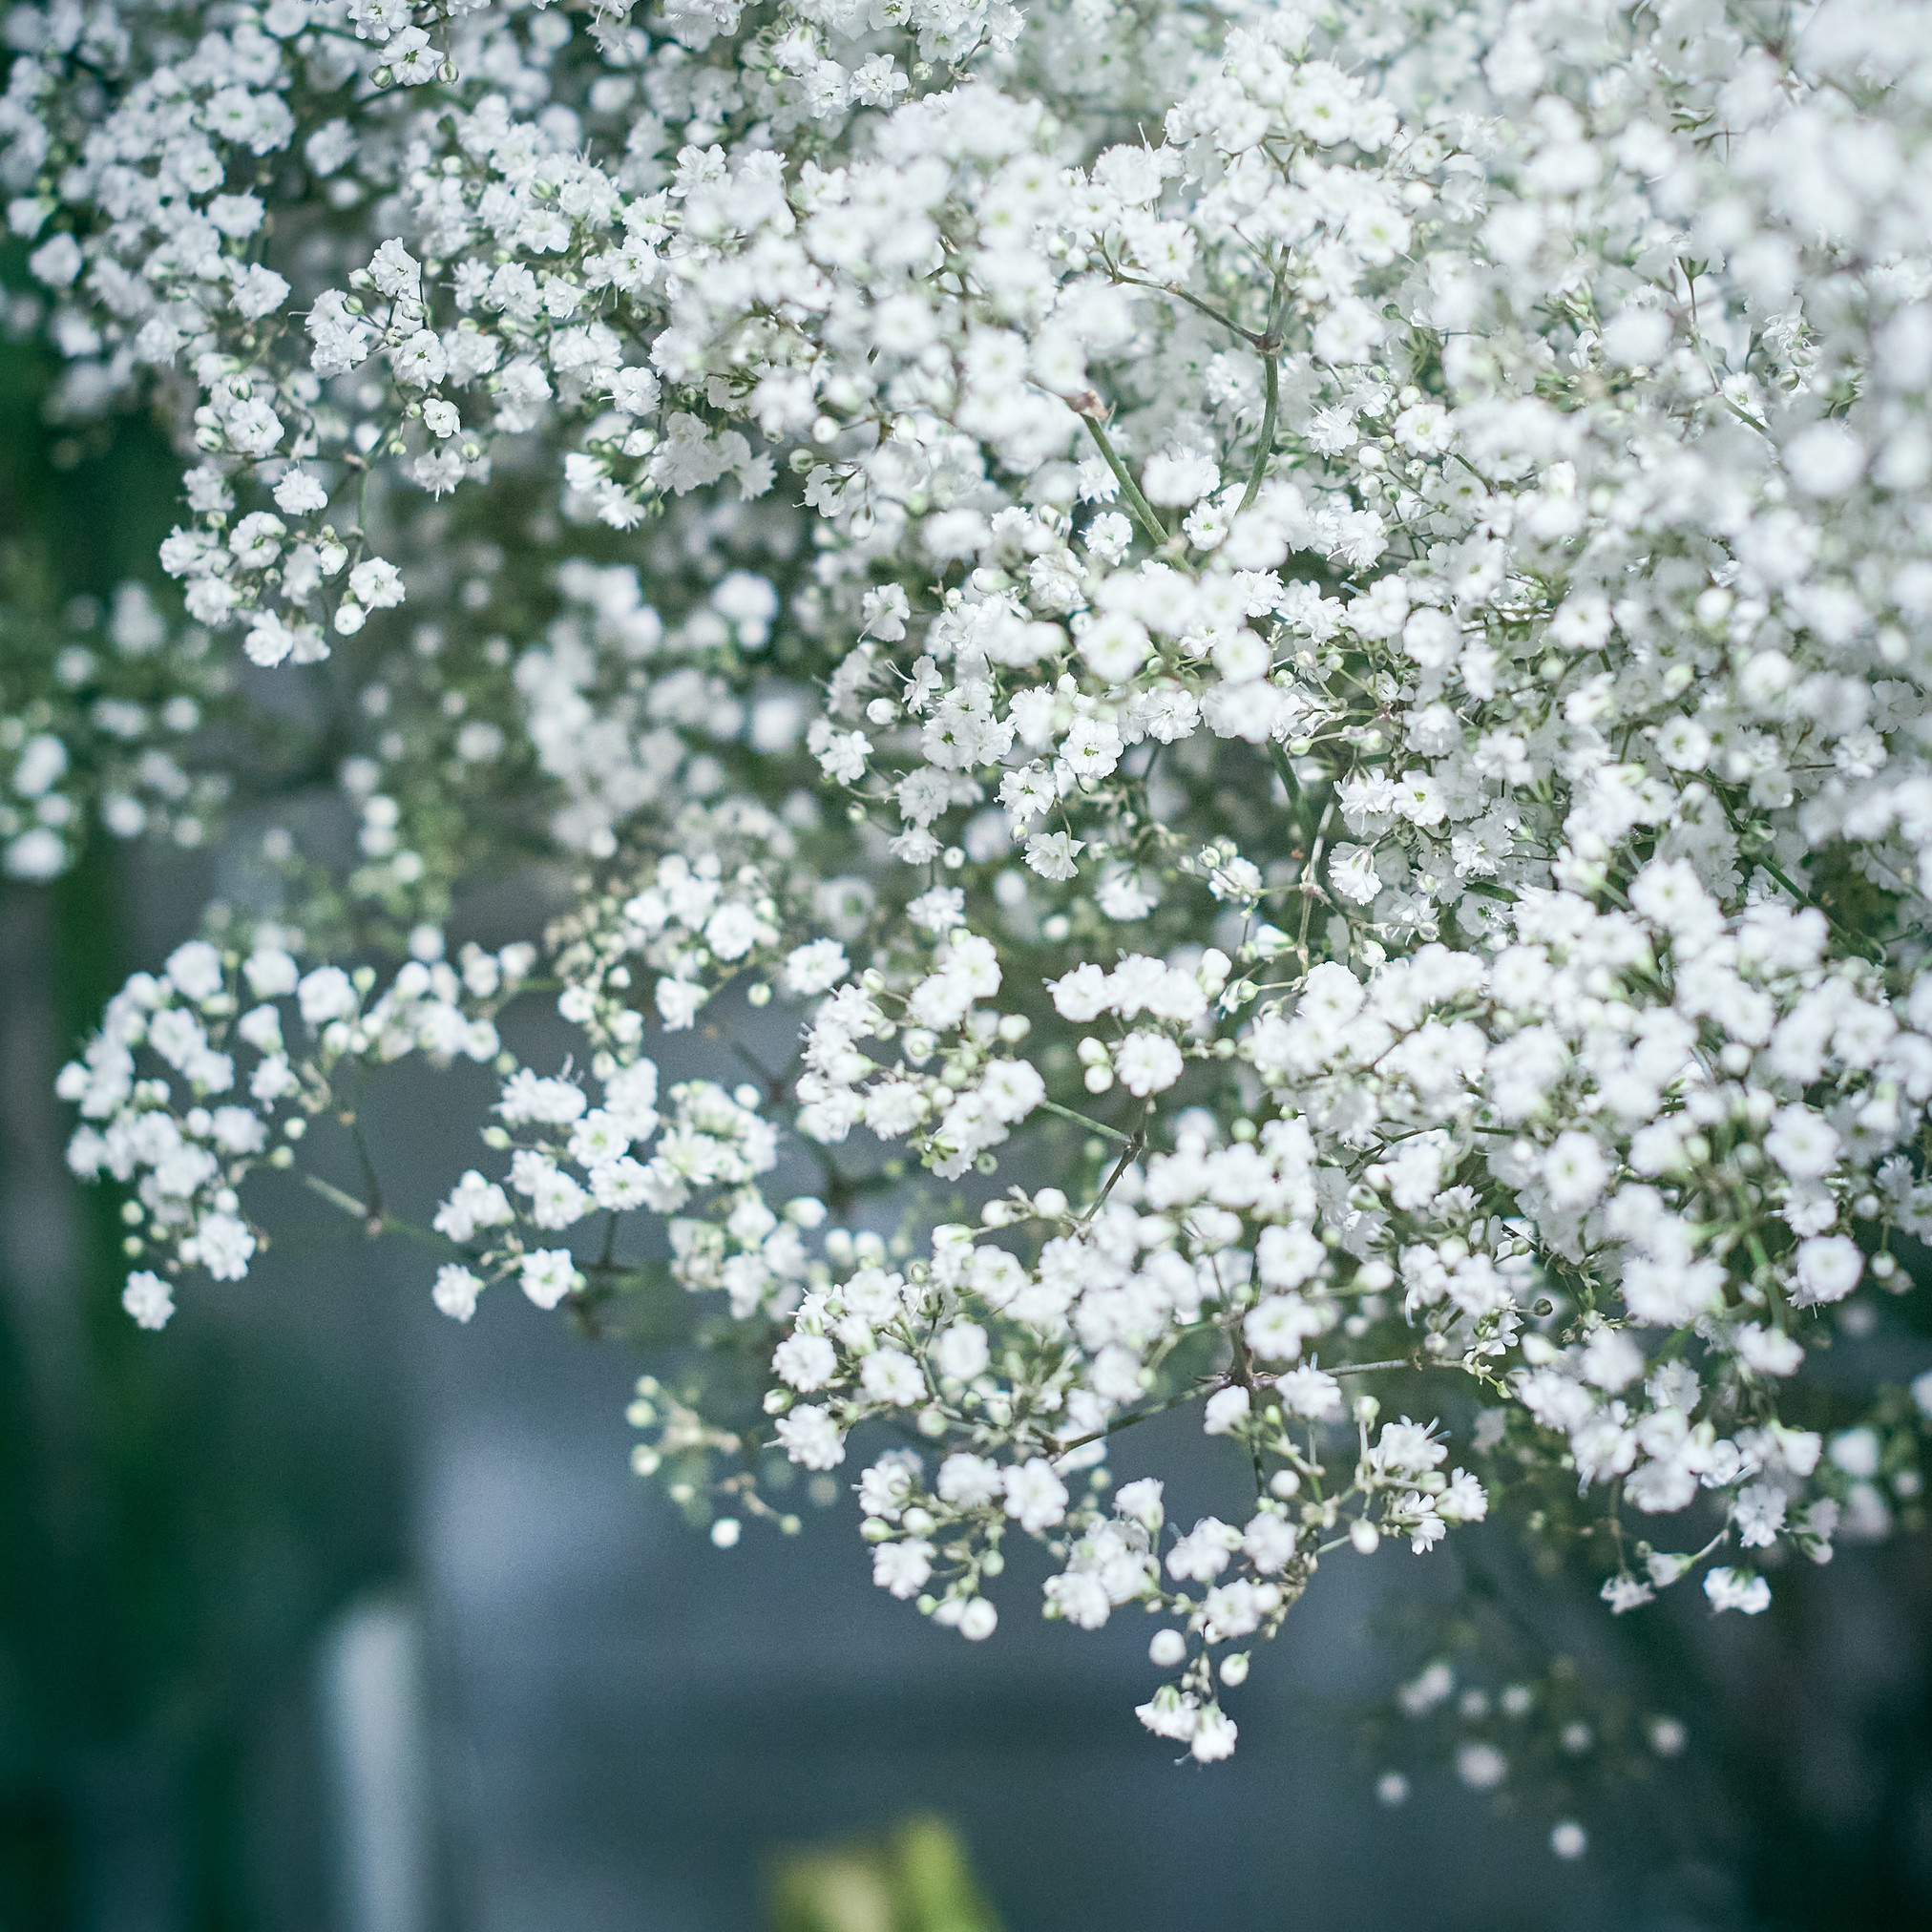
0 0 1932 1769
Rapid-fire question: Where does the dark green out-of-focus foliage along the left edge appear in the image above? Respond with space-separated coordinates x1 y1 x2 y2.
0 308 400 1932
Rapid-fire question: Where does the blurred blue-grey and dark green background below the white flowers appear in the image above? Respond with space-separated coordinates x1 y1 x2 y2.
0 282 1932 1932
